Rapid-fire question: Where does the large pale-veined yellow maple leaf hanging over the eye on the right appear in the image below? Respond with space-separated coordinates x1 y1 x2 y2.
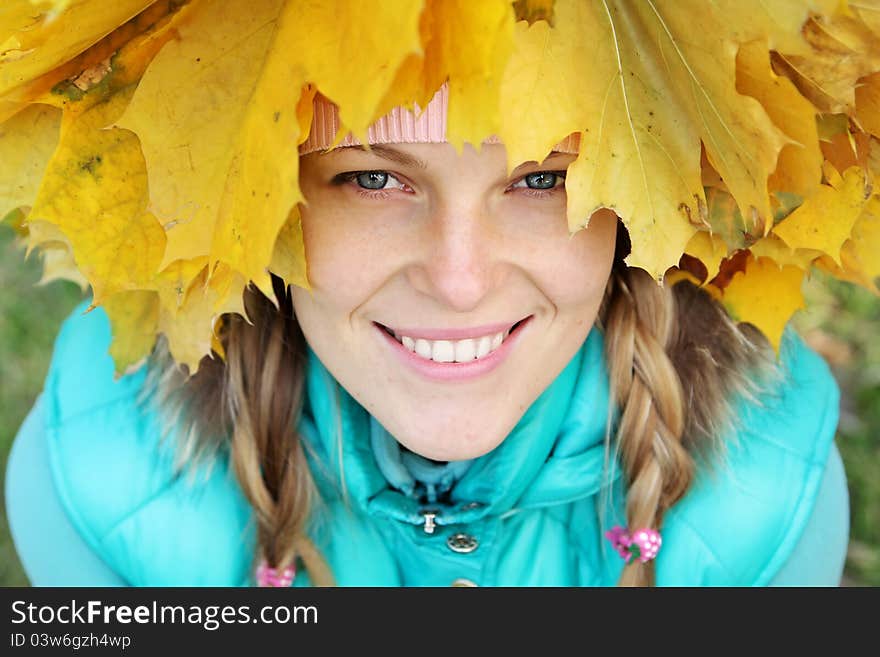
520 0 806 278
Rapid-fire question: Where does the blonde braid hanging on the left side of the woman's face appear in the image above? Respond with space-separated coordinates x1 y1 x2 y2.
226 277 332 585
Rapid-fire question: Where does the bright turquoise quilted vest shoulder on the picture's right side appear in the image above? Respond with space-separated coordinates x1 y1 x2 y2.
657 328 840 586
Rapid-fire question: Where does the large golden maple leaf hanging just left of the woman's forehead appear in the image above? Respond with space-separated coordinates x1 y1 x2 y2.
119 0 418 300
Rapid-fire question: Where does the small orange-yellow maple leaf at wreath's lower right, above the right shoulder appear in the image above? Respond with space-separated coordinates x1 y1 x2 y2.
722 255 804 354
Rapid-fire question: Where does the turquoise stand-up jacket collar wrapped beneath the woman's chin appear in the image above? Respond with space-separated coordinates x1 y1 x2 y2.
299 327 619 525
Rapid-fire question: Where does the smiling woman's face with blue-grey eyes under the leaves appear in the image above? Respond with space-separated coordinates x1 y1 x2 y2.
293 144 617 461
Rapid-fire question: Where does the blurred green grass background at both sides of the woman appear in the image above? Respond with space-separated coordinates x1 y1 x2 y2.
0 225 880 586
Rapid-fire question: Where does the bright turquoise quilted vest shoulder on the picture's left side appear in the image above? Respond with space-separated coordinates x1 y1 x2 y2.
44 302 253 586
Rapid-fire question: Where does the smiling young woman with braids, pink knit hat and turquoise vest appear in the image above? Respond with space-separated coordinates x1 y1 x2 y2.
6 3 864 586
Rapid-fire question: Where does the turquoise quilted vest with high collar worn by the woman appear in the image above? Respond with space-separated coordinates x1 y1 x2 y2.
7 303 847 586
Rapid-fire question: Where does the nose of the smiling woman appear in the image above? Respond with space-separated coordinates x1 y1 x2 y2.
410 202 501 312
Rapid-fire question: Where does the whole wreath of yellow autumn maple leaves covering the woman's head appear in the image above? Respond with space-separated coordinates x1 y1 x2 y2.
0 0 880 373
